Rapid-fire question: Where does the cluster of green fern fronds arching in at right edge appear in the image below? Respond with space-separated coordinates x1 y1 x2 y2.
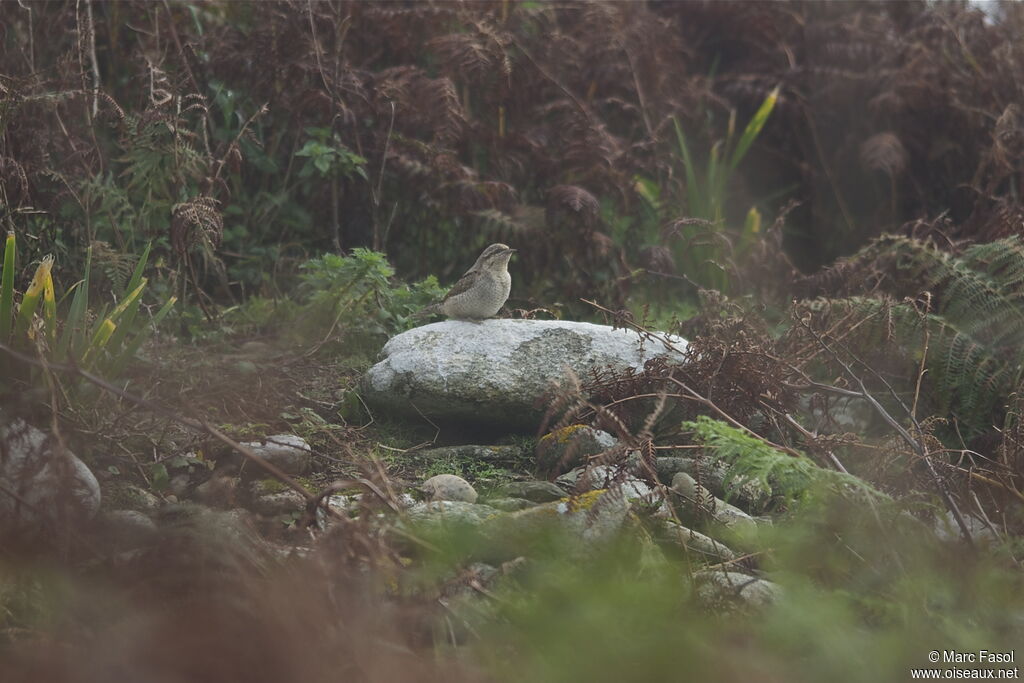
804 237 1024 435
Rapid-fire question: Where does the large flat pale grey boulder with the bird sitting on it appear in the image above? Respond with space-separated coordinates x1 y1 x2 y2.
362 319 686 430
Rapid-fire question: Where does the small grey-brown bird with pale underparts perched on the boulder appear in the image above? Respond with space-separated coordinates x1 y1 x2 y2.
417 244 517 322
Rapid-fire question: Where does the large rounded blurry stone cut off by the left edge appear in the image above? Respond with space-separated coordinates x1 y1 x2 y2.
0 415 100 528
